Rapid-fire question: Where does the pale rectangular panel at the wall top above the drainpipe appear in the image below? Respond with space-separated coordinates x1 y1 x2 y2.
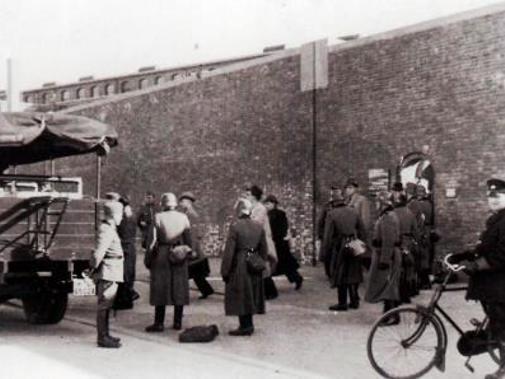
300 39 328 92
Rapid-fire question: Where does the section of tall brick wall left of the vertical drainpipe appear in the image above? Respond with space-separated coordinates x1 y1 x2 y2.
58 57 312 257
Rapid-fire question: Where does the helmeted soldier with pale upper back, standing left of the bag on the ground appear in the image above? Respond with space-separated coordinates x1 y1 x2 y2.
146 192 192 332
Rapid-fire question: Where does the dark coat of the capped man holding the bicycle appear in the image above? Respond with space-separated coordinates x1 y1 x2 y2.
467 210 505 303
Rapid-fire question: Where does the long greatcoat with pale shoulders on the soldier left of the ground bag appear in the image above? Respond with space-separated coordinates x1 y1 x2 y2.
149 210 192 306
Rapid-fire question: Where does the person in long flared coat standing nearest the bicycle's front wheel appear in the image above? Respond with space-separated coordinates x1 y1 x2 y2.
365 192 402 325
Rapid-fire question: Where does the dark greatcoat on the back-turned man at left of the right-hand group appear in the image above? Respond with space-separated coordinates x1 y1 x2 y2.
321 203 366 287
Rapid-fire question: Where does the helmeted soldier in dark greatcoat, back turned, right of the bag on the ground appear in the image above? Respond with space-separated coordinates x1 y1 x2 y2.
221 199 268 336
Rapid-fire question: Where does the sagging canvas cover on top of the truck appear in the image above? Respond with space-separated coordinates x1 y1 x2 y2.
0 112 117 172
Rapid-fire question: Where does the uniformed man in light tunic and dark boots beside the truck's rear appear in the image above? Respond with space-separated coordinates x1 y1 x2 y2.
90 200 123 348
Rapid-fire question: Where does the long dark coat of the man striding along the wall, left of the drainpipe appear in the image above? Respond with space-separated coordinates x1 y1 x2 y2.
268 208 300 275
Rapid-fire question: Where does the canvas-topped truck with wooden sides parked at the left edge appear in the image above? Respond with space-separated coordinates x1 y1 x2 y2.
0 112 118 324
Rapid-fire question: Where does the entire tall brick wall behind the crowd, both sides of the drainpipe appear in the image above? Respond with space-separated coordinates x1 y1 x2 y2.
21 6 505 258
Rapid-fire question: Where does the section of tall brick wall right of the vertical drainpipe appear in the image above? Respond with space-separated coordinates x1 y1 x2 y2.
318 8 505 250
